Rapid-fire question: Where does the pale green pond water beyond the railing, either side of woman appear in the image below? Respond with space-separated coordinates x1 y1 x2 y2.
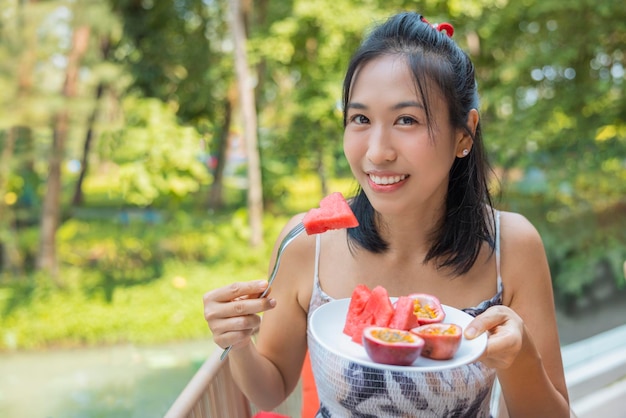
0 294 626 418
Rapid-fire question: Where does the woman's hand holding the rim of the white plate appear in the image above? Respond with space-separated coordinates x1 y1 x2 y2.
464 305 526 369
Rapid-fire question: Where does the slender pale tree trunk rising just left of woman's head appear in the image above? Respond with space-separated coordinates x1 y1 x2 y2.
229 0 263 247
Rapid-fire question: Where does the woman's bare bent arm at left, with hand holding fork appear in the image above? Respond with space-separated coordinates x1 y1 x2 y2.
204 218 314 410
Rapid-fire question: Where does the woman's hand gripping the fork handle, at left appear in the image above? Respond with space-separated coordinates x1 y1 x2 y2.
202 280 276 350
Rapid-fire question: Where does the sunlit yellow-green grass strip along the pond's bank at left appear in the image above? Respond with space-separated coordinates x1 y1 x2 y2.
0 261 263 350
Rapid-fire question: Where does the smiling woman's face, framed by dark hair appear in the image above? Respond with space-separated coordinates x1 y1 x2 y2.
343 56 471 215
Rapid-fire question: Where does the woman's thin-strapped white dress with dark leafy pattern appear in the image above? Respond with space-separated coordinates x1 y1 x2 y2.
308 212 502 418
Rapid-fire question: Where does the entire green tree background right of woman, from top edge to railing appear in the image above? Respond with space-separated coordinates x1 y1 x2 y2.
464 0 626 299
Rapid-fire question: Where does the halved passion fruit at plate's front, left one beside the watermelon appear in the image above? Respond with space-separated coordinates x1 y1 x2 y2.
363 327 424 366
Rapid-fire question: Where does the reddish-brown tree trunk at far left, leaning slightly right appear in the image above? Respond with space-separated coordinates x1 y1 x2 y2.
37 26 89 277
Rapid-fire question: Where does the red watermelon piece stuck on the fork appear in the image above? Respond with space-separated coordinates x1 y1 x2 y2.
302 192 359 235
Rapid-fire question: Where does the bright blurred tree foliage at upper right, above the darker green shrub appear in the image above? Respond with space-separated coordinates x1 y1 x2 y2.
461 0 626 204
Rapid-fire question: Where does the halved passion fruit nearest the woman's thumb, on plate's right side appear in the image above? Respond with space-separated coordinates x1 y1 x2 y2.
411 323 463 360
